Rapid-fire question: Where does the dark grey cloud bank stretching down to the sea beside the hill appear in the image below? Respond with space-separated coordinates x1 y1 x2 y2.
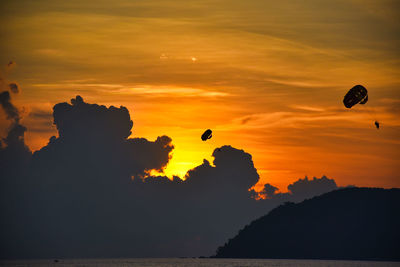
0 96 344 258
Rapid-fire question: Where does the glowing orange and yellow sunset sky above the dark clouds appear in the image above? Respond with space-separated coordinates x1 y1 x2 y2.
0 0 400 192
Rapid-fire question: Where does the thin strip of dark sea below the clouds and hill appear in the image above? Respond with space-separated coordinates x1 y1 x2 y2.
0 258 400 267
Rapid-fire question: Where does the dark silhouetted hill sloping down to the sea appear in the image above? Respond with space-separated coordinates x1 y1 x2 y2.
215 188 400 260
